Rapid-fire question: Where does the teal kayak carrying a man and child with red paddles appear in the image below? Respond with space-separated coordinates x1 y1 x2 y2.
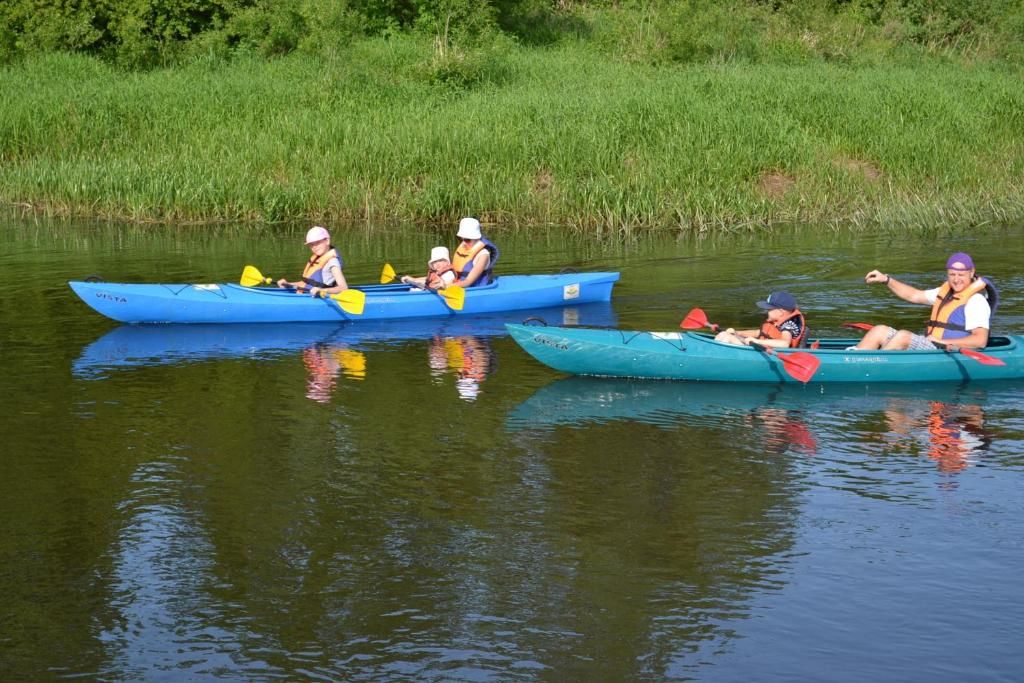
507 325 1024 383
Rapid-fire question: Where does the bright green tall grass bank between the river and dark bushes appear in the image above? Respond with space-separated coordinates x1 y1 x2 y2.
0 37 1024 231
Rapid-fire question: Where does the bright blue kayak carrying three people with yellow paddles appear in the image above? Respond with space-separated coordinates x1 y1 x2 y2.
69 272 618 324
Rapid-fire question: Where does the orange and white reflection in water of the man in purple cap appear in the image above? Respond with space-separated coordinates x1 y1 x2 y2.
885 400 992 473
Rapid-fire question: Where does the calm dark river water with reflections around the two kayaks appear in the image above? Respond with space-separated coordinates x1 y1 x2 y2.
0 217 1024 681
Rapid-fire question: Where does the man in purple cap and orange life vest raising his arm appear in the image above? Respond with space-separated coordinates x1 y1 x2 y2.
850 252 998 351
